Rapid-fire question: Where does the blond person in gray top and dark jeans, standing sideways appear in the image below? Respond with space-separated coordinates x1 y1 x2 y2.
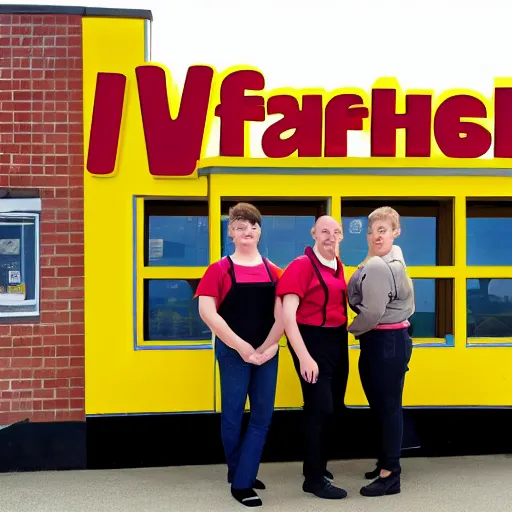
348 207 414 496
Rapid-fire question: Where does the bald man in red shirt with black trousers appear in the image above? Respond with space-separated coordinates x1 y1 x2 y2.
277 216 348 499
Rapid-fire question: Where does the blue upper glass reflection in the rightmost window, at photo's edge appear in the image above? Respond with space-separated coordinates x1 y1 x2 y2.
466 217 512 266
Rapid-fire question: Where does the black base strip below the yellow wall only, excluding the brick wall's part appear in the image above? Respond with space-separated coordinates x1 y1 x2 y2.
87 409 512 469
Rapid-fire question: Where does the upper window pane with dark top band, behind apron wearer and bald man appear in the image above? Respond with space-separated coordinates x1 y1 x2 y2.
221 201 327 268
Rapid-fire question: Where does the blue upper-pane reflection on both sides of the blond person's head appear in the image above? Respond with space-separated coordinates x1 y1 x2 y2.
340 216 437 267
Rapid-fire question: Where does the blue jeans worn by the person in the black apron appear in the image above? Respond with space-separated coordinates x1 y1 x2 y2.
215 338 279 489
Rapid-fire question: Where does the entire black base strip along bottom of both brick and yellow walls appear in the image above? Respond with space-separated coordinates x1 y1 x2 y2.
0 409 512 472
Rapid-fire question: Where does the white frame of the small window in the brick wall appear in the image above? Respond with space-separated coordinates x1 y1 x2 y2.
0 198 41 324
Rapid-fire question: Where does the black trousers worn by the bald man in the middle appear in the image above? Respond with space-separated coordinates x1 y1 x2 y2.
290 324 348 483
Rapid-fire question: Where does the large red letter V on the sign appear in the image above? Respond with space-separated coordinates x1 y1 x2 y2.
135 66 213 176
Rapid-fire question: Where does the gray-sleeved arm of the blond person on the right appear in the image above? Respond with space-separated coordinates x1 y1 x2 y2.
348 260 391 336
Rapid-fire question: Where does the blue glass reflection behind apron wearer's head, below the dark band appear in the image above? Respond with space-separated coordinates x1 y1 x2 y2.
221 215 315 268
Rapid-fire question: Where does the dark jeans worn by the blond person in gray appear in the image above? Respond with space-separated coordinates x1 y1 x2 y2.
359 329 412 471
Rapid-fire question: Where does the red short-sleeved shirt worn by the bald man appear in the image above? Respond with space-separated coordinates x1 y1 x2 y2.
277 255 347 327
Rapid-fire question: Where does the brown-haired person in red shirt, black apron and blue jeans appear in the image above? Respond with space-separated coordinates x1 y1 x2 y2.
196 203 284 507
